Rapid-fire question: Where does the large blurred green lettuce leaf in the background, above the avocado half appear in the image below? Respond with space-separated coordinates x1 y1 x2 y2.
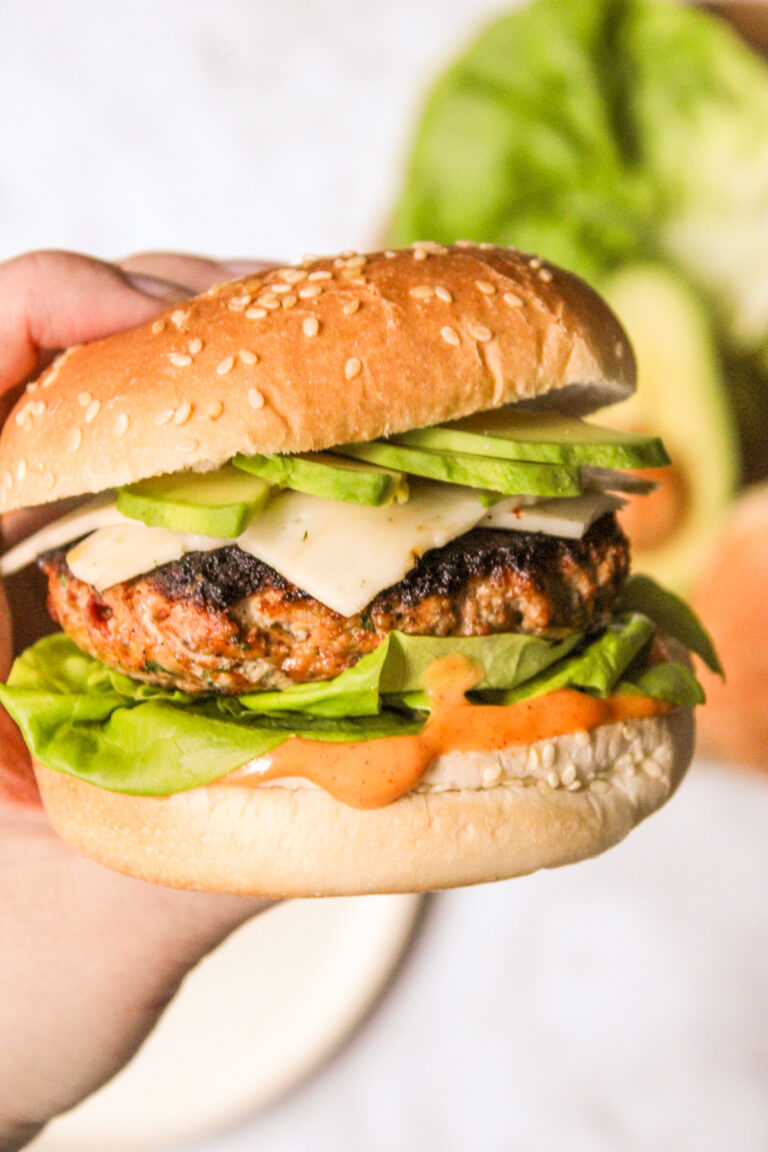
390 0 768 359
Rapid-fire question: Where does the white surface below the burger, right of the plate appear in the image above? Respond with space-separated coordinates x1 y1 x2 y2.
183 765 768 1152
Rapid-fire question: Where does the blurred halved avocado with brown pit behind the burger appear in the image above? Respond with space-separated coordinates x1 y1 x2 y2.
599 265 738 594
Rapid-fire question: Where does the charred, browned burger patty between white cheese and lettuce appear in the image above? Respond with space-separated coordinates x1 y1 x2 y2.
40 514 629 692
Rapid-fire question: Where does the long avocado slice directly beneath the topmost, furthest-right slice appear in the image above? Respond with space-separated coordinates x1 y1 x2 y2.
335 440 581 497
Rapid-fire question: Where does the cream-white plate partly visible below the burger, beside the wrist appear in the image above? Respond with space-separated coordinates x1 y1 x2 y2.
33 896 420 1152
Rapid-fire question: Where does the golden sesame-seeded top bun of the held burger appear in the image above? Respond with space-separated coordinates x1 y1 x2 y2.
0 243 634 513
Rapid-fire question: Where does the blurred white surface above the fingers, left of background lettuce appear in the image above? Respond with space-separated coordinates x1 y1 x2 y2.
0 0 509 259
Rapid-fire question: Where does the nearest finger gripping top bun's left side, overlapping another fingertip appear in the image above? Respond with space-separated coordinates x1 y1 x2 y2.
0 251 192 394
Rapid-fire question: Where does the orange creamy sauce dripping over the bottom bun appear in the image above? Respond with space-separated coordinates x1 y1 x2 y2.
218 655 670 808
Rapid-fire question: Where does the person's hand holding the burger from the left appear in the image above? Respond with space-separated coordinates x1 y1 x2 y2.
0 252 276 1152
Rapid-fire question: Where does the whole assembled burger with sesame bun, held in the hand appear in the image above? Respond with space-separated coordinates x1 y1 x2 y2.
0 243 716 896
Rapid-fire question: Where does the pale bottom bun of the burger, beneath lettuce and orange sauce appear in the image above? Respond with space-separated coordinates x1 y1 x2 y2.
36 708 693 897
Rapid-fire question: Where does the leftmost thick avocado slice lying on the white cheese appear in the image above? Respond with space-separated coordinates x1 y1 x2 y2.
117 464 269 539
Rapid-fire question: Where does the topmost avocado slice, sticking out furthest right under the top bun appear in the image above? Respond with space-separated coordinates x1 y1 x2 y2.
393 408 669 468
